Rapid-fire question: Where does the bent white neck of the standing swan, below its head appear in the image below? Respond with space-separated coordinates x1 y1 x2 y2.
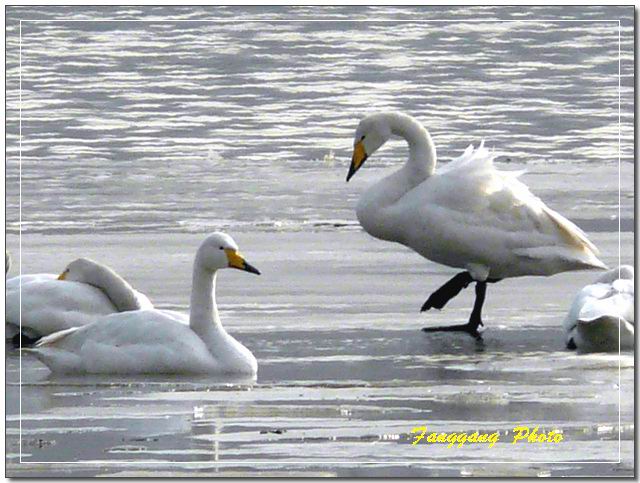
388 113 436 184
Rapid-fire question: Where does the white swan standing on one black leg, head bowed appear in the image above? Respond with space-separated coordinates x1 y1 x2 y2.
347 113 606 338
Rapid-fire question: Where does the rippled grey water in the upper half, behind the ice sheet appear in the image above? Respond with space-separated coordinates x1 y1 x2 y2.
7 7 633 233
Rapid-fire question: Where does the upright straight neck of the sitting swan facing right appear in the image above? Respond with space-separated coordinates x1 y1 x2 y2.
189 261 224 345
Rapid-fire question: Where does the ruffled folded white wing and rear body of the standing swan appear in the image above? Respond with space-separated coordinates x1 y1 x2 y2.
394 147 603 278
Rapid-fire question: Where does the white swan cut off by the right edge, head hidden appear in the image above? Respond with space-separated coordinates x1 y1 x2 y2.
563 265 635 352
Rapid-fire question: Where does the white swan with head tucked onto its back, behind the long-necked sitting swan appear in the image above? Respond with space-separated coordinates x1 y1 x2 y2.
5 258 153 345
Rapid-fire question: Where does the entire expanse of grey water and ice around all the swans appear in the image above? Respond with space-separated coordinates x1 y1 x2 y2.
6 7 634 476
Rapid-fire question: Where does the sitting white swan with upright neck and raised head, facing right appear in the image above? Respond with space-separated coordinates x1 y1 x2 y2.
29 233 260 375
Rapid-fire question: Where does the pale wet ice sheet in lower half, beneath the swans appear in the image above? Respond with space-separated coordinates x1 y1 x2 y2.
7 231 634 476
